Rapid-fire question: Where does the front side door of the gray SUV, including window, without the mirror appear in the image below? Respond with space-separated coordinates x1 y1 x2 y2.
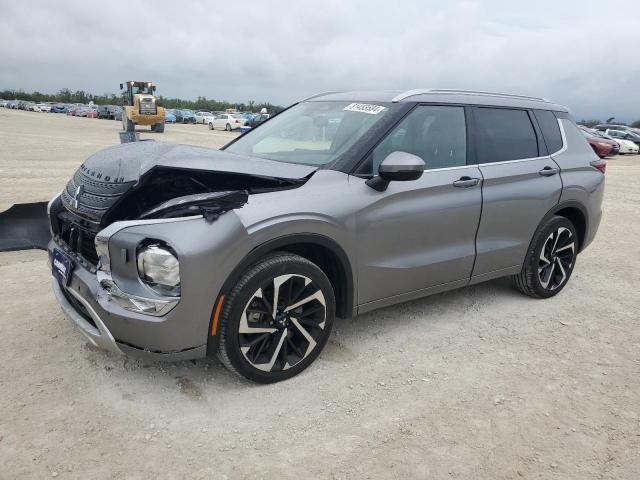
351 105 482 311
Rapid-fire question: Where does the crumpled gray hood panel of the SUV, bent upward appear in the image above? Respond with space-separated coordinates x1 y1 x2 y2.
80 141 318 183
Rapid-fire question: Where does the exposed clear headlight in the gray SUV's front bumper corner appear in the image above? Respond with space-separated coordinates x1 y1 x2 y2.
138 244 180 295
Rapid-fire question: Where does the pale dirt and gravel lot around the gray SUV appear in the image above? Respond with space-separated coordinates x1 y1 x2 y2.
0 109 640 480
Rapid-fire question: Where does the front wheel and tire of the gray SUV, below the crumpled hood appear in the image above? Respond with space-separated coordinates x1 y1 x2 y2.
218 252 335 383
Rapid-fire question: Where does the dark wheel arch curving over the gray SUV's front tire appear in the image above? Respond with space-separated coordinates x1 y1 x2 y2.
207 233 355 354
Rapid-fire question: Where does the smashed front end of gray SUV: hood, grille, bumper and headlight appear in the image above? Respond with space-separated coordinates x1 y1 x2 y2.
38 142 316 359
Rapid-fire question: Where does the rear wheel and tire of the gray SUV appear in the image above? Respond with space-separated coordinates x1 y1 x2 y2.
513 216 578 298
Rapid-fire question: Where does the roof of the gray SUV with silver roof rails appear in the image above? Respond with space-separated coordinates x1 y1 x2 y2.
305 88 569 112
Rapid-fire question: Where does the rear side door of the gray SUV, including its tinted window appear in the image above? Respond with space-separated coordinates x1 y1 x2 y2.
473 107 562 280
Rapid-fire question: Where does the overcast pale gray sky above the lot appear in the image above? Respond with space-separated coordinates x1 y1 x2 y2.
0 0 640 120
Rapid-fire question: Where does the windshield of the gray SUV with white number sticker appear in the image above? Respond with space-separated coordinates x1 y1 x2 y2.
226 102 391 165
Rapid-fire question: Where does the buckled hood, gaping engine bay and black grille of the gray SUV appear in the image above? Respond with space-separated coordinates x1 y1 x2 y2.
49 142 314 271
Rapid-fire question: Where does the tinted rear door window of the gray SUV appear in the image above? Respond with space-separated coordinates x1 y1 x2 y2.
475 107 539 163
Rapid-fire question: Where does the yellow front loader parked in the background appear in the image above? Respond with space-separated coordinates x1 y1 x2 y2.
120 80 164 133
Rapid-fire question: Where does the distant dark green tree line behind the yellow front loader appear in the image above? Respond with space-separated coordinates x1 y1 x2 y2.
0 88 284 113
